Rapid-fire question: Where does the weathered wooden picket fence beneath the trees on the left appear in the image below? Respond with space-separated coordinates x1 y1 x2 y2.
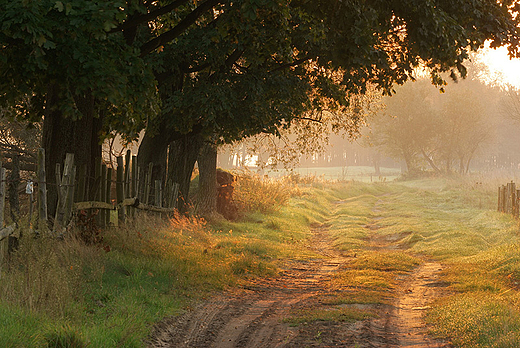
0 149 179 245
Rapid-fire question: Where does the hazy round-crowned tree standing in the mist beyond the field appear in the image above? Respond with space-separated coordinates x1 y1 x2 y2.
370 75 497 174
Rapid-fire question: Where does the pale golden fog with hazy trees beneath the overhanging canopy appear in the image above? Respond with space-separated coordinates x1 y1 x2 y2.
219 51 520 178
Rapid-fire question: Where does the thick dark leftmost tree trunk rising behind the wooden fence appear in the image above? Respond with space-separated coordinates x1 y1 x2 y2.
42 85 103 216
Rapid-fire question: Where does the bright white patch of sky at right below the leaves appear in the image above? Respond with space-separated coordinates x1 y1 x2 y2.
477 42 520 88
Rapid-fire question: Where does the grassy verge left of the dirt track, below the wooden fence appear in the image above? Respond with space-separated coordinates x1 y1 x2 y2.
0 173 330 348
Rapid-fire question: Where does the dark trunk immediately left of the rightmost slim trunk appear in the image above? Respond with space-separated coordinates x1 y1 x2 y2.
168 133 202 214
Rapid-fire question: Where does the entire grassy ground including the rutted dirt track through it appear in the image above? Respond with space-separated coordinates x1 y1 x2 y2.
0 172 520 347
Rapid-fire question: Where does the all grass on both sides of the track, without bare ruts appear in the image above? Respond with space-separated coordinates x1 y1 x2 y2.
0 177 520 347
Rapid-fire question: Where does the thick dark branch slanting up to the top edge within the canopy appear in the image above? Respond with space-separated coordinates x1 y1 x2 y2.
141 0 223 57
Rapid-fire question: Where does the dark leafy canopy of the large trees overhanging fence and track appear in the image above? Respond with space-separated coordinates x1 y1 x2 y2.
0 0 520 215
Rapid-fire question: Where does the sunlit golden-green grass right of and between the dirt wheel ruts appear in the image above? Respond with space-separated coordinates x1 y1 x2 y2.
326 179 520 347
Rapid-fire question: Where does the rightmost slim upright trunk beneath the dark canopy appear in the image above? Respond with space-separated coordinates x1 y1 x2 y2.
197 141 217 216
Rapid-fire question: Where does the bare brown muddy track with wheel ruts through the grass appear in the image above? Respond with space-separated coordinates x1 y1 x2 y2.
149 198 450 348
